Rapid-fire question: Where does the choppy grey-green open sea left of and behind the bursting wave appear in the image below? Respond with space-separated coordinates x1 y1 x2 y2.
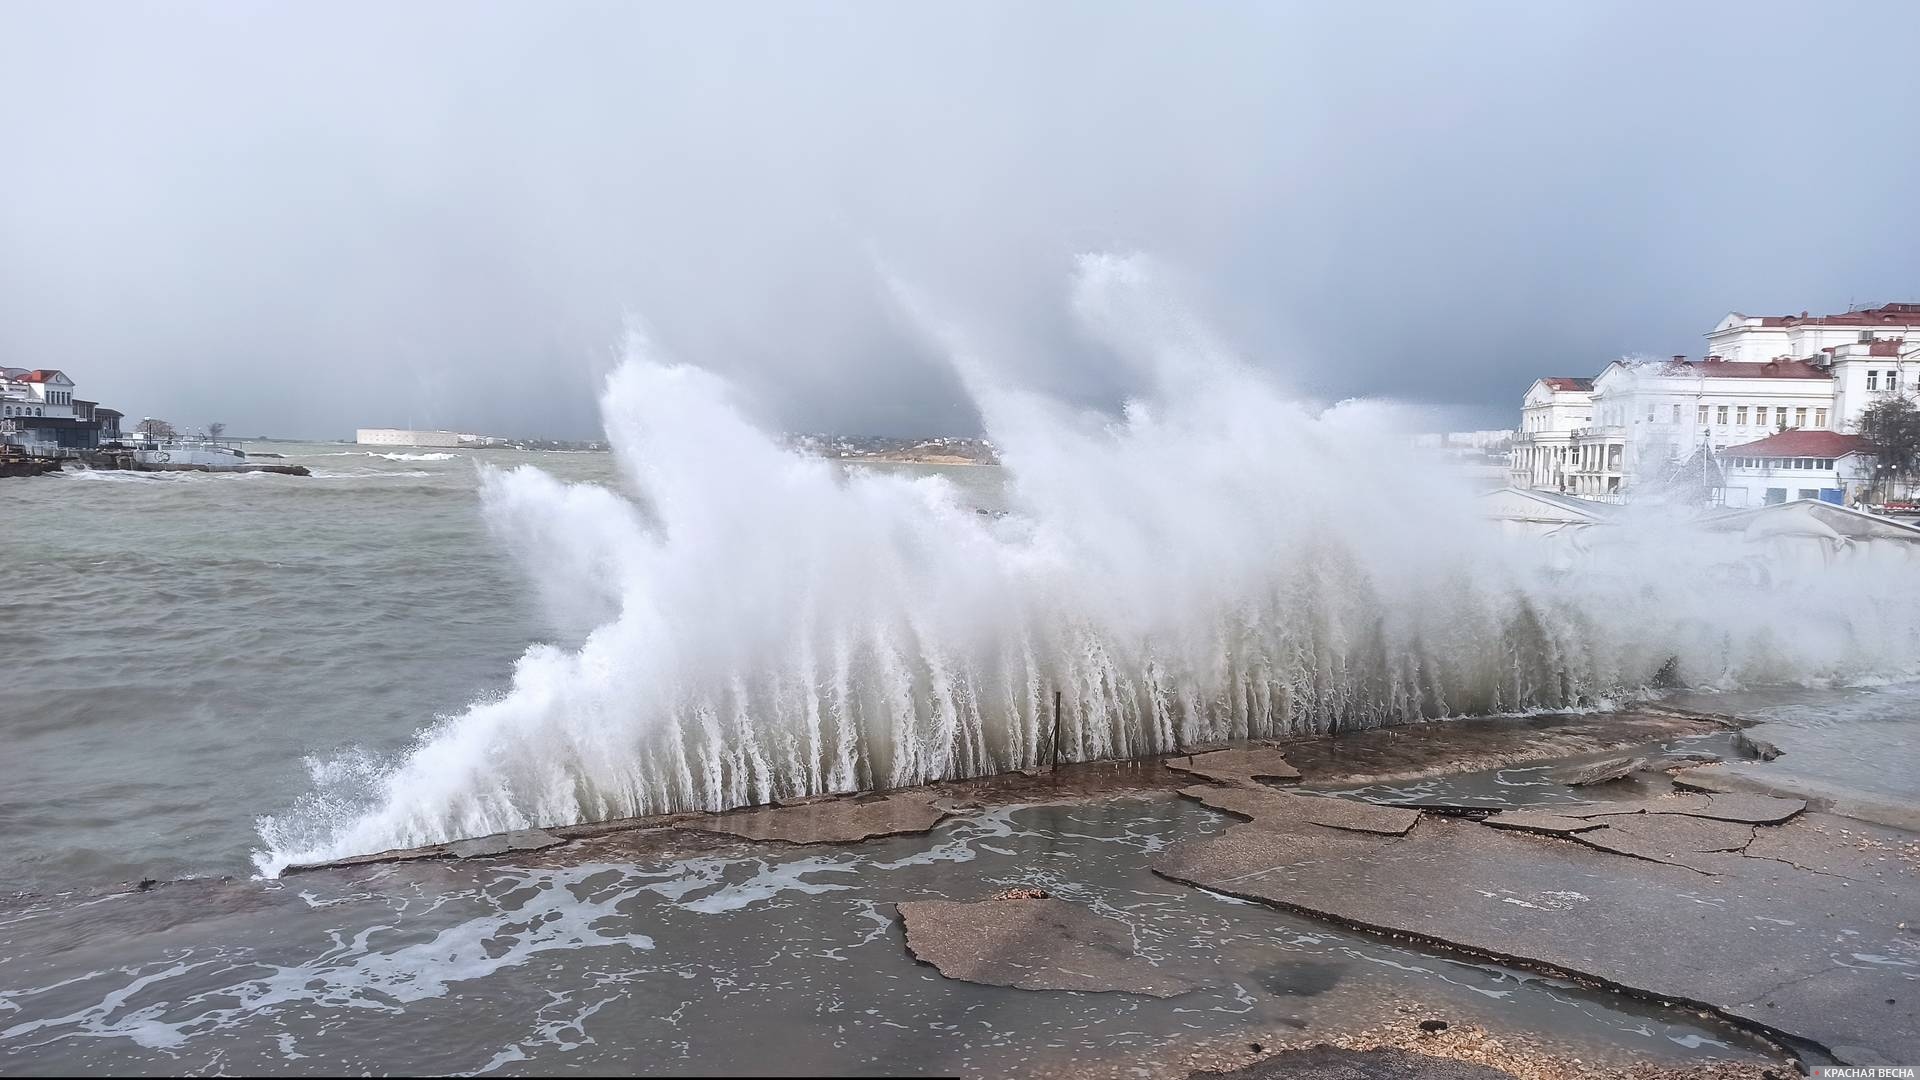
0 442 998 892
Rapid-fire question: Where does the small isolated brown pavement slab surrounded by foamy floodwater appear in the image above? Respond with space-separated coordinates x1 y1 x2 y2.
899 897 1206 997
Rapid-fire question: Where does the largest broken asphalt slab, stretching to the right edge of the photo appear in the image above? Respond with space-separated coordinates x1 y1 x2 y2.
1154 815 1920 1061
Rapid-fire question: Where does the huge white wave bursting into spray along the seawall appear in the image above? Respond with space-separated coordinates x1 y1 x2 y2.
255 258 1920 874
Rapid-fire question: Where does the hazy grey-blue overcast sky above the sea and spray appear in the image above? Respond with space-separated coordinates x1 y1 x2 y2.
0 0 1920 436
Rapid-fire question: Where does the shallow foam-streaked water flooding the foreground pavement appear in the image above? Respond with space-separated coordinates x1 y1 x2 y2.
0 794 1764 1076
